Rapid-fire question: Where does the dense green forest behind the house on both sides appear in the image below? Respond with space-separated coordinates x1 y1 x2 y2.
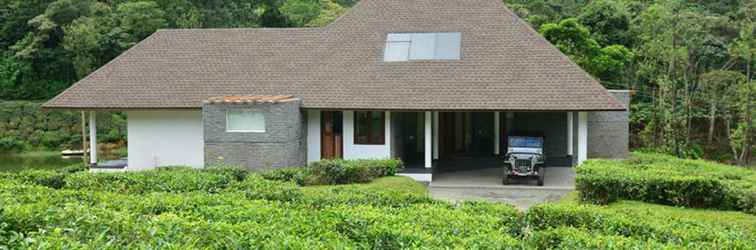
0 0 756 164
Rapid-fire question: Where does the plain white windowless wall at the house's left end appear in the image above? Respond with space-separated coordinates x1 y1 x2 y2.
127 110 205 170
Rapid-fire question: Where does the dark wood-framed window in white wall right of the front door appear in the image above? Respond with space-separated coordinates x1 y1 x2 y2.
354 111 386 145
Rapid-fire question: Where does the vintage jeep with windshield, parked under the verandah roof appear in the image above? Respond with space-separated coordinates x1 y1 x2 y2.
502 135 546 186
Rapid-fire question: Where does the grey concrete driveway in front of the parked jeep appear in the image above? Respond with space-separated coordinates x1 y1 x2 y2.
428 167 575 210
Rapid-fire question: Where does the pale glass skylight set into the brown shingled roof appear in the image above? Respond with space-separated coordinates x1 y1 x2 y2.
383 32 462 62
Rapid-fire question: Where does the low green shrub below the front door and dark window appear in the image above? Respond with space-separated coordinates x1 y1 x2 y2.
308 160 403 184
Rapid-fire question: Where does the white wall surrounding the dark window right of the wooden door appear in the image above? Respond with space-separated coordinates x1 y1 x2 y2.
342 111 391 159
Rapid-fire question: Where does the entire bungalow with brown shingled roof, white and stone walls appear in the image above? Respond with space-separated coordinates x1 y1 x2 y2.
44 0 629 181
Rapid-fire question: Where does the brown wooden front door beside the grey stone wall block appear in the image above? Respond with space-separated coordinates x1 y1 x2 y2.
320 111 344 159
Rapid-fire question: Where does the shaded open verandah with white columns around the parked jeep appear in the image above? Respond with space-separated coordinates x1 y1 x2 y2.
391 111 588 186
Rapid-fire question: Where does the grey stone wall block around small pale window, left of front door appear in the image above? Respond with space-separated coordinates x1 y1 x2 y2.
202 100 307 170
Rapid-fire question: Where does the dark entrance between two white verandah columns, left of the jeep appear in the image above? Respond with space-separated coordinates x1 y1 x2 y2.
438 112 494 159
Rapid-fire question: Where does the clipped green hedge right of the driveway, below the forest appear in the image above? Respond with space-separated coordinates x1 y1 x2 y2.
576 153 756 214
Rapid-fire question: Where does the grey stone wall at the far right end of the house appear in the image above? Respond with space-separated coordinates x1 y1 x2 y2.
588 90 630 158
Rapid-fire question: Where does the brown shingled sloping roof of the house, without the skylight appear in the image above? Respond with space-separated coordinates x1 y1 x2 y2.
45 0 625 111
